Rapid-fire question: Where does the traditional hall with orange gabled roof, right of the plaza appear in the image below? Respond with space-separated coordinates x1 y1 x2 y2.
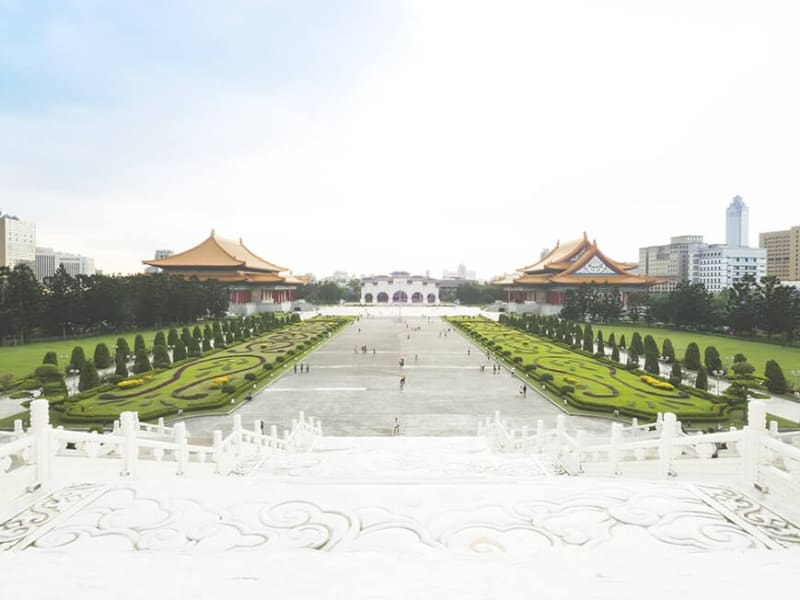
494 233 664 314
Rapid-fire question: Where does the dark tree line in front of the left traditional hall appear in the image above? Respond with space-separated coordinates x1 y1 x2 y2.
0 264 229 344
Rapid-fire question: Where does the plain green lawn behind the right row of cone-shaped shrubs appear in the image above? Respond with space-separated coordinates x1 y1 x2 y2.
592 323 800 383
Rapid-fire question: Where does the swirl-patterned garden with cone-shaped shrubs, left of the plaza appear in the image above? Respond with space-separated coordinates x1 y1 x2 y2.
1 315 352 425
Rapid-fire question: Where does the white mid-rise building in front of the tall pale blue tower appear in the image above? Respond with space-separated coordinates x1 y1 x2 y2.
691 244 767 294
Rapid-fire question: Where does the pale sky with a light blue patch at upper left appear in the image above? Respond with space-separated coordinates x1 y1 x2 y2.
0 0 800 278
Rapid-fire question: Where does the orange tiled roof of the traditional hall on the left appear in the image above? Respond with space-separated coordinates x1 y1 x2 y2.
142 229 287 273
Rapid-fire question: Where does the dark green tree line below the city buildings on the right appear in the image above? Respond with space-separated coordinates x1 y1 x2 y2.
560 275 800 342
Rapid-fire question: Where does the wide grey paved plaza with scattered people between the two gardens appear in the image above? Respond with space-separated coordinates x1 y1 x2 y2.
187 317 610 436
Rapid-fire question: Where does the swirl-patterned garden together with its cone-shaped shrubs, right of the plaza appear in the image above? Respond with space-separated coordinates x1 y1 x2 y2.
448 315 785 426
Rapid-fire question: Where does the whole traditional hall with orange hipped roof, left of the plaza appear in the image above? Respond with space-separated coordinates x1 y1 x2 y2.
142 229 305 314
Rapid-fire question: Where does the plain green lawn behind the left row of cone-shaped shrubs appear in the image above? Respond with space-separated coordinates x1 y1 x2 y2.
0 328 164 379
